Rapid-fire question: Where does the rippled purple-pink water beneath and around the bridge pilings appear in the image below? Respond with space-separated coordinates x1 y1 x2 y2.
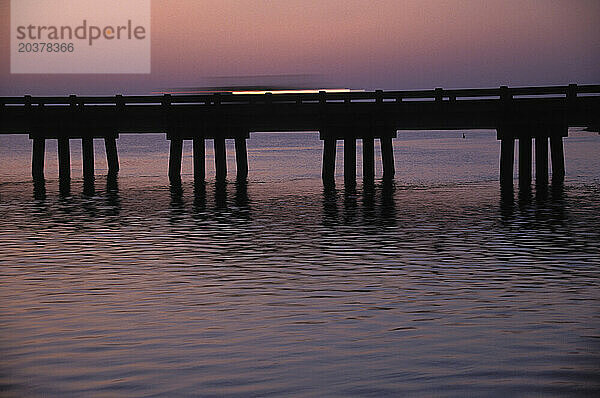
0 131 600 397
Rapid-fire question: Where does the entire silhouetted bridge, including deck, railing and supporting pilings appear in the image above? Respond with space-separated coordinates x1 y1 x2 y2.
0 84 600 187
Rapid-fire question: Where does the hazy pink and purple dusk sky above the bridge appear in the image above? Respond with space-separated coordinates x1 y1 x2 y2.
0 0 600 95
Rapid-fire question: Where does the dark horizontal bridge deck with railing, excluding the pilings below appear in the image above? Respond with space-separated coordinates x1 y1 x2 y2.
0 85 600 139
